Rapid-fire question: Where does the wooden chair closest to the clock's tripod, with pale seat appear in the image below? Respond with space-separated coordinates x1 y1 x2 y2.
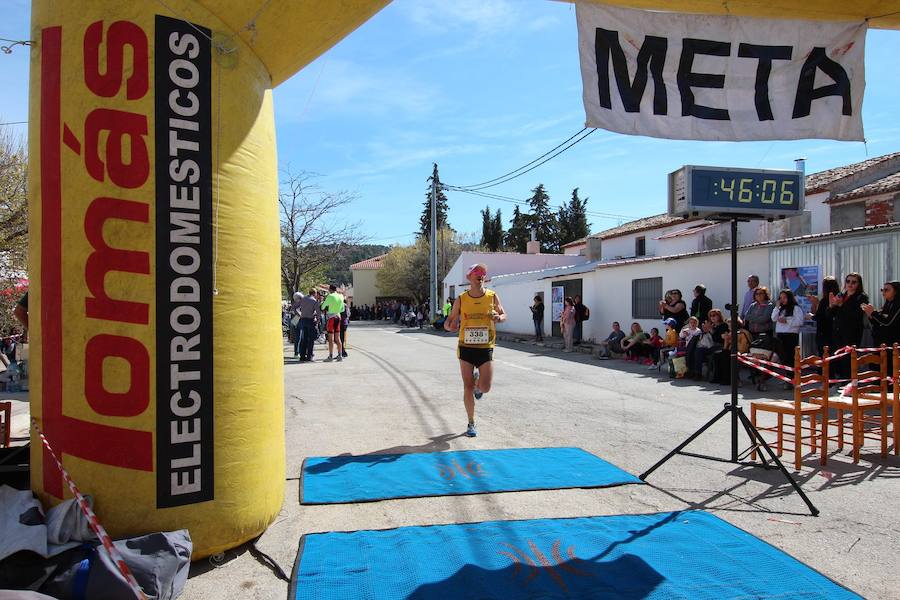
750 347 828 471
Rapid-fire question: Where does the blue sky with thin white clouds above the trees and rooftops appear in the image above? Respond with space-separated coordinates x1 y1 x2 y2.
0 0 900 243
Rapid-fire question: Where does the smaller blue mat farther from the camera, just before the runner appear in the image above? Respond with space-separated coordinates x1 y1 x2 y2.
300 448 643 504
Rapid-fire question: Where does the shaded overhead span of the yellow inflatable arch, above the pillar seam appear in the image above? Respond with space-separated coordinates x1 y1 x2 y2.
197 0 900 86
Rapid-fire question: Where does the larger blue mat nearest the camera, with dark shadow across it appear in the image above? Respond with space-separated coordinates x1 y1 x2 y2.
288 511 860 600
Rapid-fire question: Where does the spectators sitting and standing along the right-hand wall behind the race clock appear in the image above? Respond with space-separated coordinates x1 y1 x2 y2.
588 272 900 378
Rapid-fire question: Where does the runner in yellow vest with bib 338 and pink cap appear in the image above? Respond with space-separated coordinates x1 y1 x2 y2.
444 264 506 437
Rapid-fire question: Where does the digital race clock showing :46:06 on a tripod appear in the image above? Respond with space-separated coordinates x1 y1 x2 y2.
669 165 805 219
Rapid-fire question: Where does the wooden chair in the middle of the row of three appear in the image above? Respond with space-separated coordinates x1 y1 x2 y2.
825 346 891 463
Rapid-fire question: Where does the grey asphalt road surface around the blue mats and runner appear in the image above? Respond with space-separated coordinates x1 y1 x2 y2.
182 323 900 599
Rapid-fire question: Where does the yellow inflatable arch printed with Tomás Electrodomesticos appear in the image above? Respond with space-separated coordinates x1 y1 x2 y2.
29 0 900 559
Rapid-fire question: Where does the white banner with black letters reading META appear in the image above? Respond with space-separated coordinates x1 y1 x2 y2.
577 2 866 140
